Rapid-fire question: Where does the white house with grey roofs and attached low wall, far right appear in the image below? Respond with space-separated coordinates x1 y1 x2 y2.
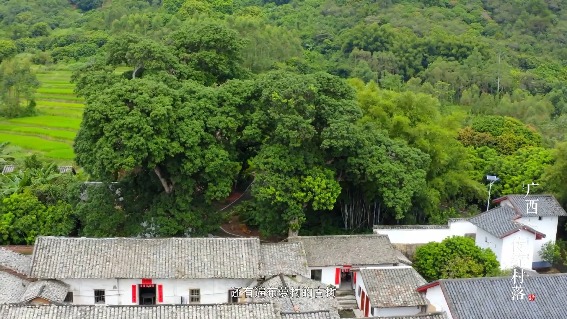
374 195 567 269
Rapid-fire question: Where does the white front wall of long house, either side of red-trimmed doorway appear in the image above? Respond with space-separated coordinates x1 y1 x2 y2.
61 279 255 305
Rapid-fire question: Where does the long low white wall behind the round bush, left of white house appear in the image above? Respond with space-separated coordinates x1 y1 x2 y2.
374 220 477 244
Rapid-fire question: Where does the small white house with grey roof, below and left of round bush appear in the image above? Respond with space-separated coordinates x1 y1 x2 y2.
356 266 428 317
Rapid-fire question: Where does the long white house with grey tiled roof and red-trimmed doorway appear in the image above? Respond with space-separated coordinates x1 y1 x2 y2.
31 237 261 305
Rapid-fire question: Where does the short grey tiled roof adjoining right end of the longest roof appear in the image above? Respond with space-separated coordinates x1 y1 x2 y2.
260 242 311 277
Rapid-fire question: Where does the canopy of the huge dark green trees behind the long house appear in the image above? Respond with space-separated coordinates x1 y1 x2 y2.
75 19 430 235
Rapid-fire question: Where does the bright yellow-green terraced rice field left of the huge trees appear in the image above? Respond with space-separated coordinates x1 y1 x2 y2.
0 68 83 164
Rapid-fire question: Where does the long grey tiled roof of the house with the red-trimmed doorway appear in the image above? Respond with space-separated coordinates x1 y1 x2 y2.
31 237 260 279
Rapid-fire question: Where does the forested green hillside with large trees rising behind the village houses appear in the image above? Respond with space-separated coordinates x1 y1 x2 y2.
0 0 567 243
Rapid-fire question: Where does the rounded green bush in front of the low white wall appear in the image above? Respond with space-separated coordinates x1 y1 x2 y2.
413 236 500 281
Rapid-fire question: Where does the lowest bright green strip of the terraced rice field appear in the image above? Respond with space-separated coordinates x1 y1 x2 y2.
0 133 74 160
